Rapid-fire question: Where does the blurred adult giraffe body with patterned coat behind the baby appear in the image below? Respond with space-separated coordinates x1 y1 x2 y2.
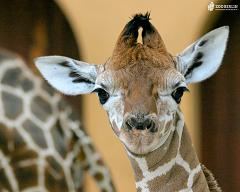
0 50 115 192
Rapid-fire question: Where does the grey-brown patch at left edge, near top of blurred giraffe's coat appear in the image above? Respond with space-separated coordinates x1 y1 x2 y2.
2 68 22 87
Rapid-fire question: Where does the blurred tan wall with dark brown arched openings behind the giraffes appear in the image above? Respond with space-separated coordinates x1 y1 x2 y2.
0 0 240 192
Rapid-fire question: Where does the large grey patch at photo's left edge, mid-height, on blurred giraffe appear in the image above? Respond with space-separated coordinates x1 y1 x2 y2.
2 91 23 120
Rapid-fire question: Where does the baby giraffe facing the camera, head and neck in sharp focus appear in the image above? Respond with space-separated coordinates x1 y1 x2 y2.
35 13 229 192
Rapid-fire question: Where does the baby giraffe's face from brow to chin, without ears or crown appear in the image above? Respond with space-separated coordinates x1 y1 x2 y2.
94 60 187 154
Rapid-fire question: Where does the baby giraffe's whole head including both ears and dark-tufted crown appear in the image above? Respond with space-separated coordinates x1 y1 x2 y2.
35 14 229 154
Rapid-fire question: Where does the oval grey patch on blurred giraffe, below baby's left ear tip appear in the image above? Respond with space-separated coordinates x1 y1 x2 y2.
31 96 52 122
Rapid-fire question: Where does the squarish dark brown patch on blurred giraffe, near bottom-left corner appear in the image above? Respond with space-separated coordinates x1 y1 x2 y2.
14 165 38 190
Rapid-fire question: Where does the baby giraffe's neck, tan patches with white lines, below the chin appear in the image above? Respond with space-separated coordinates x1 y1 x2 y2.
128 112 209 192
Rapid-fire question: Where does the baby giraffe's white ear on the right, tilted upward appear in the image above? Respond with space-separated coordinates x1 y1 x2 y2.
176 26 229 83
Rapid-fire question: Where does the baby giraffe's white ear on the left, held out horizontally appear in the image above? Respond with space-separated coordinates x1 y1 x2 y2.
34 56 101 95
